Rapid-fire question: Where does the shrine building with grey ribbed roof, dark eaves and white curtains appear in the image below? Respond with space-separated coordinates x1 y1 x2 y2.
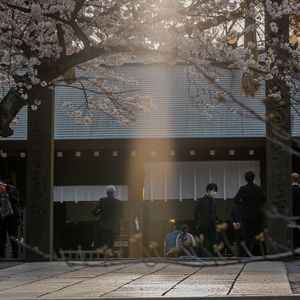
0 63 300 256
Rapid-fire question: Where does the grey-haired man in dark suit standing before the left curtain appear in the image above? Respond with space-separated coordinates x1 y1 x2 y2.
92 185 121 249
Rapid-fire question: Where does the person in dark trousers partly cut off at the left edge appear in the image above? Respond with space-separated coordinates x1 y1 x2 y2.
0 181 20 258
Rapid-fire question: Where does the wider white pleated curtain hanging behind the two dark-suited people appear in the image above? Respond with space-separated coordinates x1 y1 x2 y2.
144 161 260 201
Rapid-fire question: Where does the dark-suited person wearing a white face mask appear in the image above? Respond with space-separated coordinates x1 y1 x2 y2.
194 183 218 255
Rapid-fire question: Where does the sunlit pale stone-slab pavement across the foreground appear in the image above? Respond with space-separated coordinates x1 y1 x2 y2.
0 260 300 300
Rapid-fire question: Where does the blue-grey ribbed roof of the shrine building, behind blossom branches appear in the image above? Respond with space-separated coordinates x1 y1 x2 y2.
2 63 300 140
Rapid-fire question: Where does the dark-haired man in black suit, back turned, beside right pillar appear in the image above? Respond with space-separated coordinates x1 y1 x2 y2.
233 170 266 255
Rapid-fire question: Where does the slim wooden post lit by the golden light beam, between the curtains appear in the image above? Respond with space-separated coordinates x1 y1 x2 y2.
128 157 144 257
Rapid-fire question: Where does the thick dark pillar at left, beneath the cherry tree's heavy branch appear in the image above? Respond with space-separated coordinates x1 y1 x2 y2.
25 89 54 261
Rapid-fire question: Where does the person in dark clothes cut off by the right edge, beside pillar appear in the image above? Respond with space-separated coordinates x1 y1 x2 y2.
292 173 300 249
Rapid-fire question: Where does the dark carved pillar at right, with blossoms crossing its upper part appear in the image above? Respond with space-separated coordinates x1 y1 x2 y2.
265 0 292 253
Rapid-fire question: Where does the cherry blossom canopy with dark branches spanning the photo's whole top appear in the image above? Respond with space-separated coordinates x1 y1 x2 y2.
0 0 300 137
